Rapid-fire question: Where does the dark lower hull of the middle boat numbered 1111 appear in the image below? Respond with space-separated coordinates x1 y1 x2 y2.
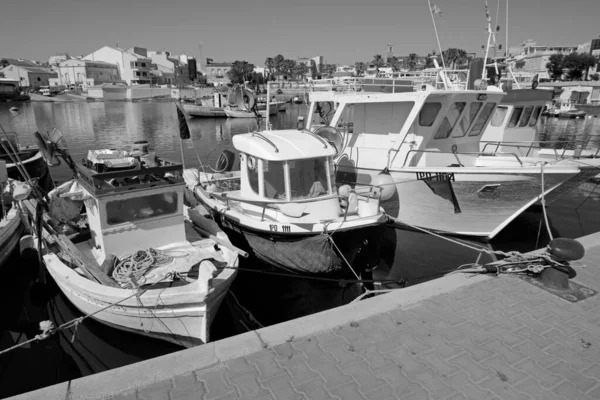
211 210 384 279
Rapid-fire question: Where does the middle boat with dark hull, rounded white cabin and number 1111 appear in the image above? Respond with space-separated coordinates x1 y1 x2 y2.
184 130 386 277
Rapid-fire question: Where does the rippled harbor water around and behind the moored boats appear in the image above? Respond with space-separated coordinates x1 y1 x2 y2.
0 101 600 398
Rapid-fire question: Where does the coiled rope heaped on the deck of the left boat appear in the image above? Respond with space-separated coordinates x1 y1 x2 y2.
112 248 173 289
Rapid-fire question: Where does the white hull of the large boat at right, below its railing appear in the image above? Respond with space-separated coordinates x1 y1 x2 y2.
336 166 577 239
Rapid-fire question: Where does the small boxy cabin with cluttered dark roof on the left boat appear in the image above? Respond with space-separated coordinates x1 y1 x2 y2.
77 144 186 262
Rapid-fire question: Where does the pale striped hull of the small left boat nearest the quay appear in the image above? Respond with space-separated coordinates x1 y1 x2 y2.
44 254 235 347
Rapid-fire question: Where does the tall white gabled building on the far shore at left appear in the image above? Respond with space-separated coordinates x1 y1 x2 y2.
83 46 152 85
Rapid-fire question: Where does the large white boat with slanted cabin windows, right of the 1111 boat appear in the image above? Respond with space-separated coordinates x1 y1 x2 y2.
307 78 585 238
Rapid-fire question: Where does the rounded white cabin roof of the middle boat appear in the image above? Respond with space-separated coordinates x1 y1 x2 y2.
233 129 336 161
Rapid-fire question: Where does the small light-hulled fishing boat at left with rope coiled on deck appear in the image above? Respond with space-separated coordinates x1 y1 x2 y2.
23 135 239 347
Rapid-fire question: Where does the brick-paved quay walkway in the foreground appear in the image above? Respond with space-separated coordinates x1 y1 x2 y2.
11 238 600 400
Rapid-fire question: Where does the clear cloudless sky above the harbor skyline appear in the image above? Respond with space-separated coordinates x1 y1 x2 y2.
0 0 600 66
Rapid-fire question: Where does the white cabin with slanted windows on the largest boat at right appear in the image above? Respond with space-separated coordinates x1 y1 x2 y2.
308 89 505 170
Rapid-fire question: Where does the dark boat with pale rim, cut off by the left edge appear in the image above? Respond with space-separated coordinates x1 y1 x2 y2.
0 132 54 191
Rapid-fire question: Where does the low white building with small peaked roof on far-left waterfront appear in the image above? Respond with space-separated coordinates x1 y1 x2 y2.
50 59 124 90
